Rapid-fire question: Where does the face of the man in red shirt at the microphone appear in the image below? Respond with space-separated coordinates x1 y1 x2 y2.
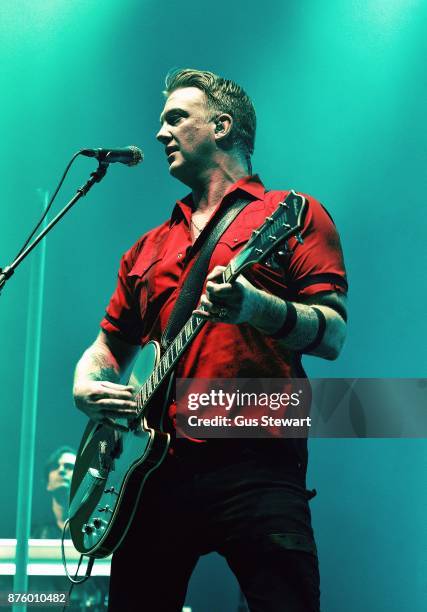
156 87 216 186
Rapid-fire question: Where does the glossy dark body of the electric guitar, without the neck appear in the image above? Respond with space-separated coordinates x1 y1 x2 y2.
69 342 170 558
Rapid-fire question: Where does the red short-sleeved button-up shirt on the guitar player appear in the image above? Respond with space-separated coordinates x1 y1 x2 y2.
101 176 347 378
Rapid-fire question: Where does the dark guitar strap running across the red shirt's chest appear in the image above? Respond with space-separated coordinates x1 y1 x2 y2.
161 198 252 349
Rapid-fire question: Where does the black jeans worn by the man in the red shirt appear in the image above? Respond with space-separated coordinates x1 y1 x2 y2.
109 450 320 612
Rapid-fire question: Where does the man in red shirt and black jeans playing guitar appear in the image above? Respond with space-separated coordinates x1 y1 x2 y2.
74 69 347 612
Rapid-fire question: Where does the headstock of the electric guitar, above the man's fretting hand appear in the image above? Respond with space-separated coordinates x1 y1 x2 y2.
230 190 307 276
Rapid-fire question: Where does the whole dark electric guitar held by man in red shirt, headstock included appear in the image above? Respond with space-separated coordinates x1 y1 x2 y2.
69 191 307 558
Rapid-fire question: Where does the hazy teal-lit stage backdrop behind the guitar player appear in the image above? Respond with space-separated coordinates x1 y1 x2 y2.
0 0 427 612
